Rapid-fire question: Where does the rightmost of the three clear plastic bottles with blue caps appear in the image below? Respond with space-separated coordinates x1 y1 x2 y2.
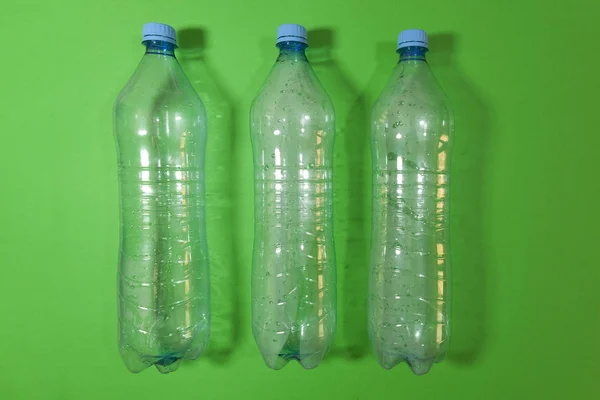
369 30 453 374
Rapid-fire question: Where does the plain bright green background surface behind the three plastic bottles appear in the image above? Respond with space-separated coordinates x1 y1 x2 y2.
0 0 600 400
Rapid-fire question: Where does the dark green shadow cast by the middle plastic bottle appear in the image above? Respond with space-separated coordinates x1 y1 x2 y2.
307 29 370 359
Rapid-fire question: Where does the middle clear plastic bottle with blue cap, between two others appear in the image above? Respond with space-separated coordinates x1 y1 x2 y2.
250 24 336 369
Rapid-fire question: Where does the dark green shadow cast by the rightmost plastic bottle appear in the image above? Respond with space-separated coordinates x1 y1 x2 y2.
427 33 490 365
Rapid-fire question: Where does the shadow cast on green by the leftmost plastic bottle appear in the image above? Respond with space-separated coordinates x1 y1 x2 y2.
177 27 241 363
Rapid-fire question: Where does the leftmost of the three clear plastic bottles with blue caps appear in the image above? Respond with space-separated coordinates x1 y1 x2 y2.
114 23 210 373
